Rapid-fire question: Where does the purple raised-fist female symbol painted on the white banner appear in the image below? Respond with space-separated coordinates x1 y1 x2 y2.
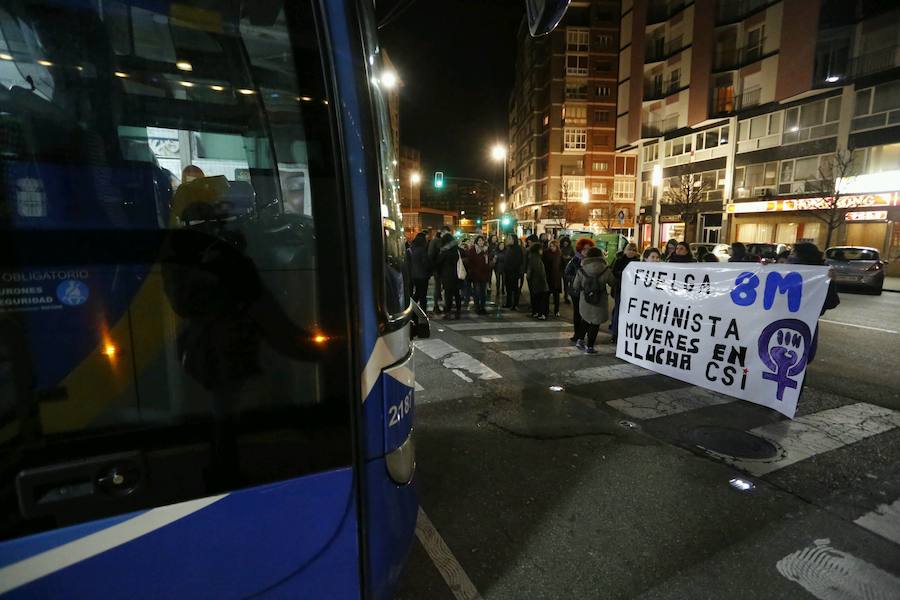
759 319 812 400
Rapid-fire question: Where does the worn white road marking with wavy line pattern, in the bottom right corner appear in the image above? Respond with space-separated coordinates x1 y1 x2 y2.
775 539 900 600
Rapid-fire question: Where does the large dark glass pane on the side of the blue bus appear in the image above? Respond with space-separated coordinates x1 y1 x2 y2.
0 0 352 539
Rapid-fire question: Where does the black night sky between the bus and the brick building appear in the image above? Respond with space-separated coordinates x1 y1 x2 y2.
379 0 525 183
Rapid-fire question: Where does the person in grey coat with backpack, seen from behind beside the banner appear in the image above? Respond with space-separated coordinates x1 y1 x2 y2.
572 248 613 354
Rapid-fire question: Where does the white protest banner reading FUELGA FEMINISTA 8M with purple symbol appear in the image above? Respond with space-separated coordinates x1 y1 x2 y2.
616 262 828 418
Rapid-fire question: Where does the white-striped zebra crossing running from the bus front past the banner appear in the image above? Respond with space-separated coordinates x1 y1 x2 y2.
417 315 900 500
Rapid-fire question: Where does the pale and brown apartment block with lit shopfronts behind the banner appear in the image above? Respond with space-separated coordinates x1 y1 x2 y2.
616 0 900 268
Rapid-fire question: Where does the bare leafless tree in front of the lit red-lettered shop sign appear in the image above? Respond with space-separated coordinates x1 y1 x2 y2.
797 150 861 248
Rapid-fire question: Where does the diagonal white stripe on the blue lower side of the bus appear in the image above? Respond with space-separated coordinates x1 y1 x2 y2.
0 494 227 594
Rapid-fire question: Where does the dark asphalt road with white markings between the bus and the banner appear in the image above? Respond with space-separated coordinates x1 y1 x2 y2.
397 284 900 600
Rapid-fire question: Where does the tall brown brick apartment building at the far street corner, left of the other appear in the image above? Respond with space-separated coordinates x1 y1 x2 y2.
507 0 637 239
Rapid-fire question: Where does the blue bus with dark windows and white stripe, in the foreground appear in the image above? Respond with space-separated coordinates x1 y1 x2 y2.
0 0 567 598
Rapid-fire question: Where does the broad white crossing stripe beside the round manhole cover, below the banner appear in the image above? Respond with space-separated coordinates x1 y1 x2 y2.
722 402 900 476
